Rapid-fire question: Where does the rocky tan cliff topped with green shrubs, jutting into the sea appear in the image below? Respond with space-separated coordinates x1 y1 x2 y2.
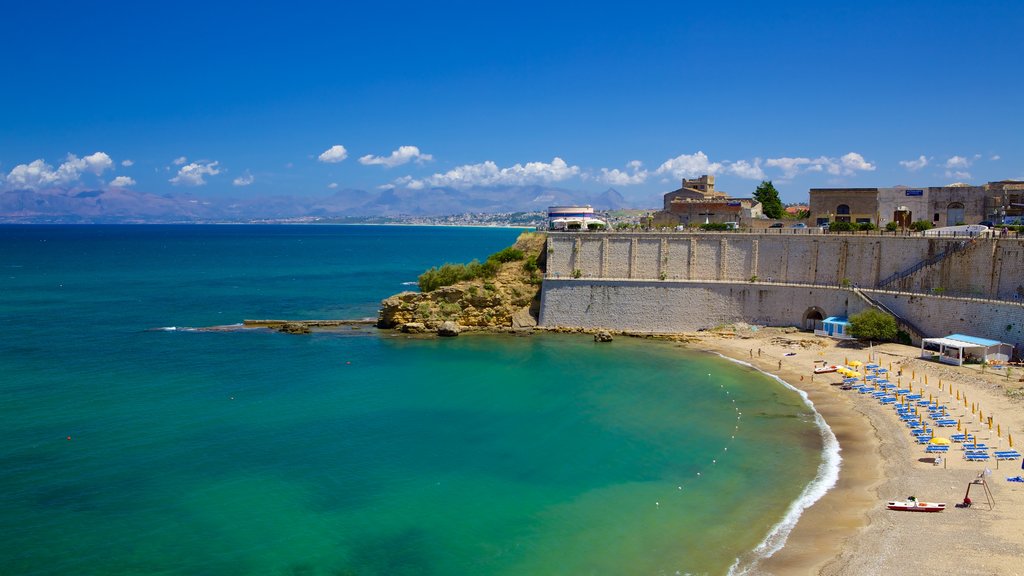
377 232 547 335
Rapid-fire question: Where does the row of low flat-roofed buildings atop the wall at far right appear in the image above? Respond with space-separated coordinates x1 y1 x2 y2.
810 180 1024 227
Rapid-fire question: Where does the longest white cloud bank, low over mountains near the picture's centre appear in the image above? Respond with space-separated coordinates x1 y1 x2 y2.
393 157 580 190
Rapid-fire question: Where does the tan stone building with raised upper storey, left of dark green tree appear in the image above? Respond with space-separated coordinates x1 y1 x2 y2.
651 174 762 228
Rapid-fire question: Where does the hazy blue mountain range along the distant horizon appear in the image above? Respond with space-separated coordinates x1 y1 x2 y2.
0 186 651 222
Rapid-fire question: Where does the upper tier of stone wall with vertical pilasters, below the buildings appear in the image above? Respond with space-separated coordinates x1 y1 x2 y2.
547 231 1024 299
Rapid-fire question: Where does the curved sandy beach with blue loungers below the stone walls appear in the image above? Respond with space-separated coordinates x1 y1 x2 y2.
691 328 1024 575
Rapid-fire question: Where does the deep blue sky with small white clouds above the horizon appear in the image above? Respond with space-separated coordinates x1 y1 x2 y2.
0 0 1024 207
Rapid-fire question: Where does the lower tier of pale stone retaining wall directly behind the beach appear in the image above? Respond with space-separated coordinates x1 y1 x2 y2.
540 279 1024 355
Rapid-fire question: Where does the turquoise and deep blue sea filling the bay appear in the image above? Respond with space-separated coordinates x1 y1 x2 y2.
0 225 838 576
